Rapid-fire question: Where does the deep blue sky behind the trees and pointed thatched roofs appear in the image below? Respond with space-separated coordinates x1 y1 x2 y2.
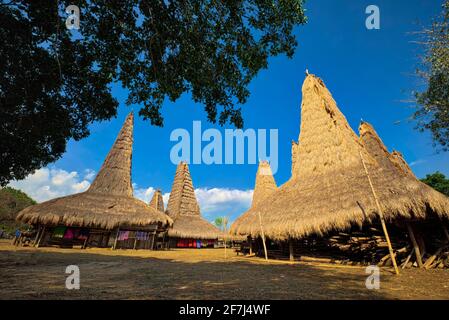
13 0 449 224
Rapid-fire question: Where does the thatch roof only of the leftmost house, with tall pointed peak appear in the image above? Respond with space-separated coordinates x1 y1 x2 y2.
17 113 173 229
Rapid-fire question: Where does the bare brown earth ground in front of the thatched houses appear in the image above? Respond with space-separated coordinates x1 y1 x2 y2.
0 240 449 299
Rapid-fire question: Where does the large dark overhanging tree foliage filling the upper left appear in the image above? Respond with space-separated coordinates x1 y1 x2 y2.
0 0 305 185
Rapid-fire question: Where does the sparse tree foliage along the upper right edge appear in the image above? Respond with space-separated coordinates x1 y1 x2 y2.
414 0 449 151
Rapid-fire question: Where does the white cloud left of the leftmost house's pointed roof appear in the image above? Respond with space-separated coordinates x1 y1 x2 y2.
9 168 95 202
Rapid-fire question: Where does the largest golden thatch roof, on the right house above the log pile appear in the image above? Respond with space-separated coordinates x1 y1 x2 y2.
231 75 449 239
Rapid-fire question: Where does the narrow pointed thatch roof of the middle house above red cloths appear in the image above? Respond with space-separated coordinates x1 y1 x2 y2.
166 162 224 239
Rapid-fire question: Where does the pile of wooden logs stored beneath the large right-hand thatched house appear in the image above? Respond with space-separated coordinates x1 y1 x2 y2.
268 221 449 269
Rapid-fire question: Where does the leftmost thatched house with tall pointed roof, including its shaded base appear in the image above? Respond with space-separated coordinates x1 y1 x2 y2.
17 113 173 249
